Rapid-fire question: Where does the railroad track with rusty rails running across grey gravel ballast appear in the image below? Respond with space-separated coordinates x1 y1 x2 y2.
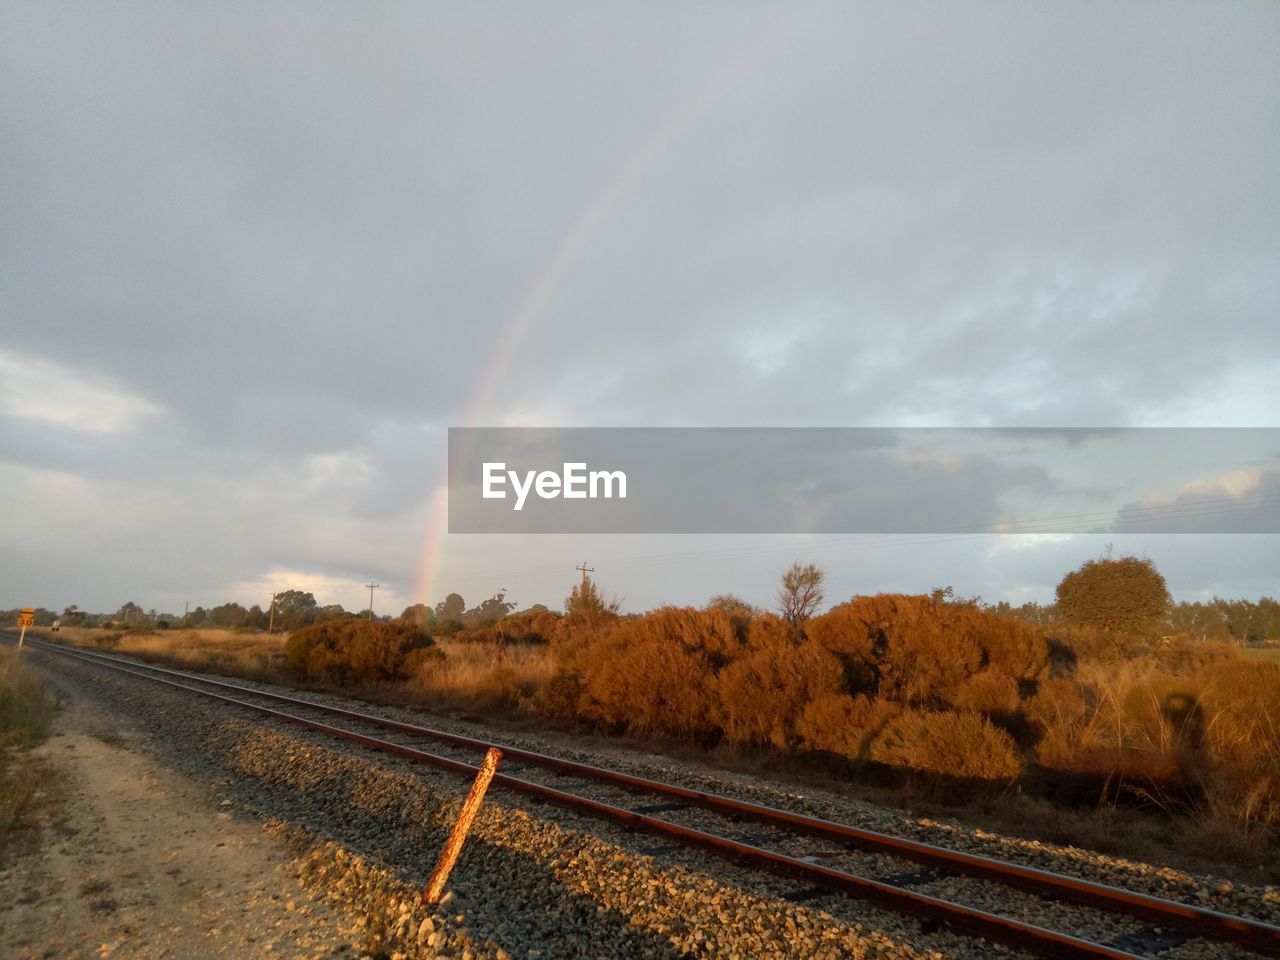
17 640 1280 960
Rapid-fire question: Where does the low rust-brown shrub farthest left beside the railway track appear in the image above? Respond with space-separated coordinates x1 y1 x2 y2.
284 618 431 684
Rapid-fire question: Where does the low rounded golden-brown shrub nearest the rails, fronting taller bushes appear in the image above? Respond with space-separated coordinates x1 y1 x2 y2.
870 708 1023 781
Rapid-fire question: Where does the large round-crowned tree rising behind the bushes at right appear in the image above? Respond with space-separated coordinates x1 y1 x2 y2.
1057 554 1172 632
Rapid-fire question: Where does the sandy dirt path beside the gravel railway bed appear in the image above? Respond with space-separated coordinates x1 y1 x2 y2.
0 701 358 959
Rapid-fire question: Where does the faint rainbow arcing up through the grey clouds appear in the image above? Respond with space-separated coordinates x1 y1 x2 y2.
413 17 812 603
